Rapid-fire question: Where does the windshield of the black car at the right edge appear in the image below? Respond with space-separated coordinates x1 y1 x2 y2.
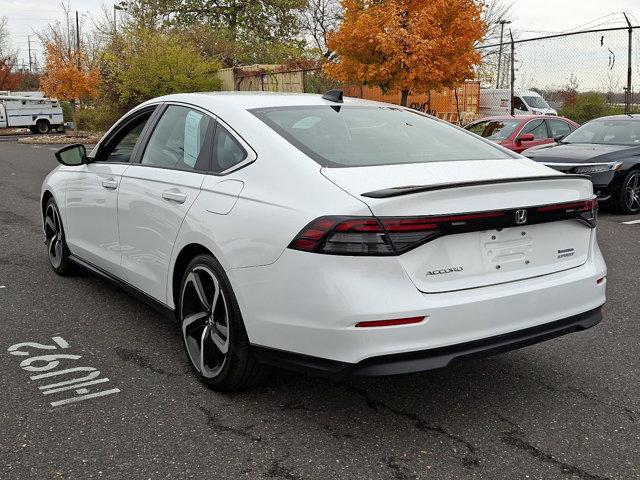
562 119 640 146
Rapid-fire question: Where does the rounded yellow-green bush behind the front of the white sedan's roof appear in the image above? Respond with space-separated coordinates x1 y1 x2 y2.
100 30 220 112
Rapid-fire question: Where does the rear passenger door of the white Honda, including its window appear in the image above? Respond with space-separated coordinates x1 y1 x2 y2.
118 104 215 302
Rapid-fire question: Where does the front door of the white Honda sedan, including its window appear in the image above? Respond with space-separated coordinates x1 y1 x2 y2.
65 110 153 275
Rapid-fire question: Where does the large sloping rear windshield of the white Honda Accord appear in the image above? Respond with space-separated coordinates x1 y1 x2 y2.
251 105 512 167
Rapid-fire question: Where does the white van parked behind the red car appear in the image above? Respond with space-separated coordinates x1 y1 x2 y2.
480 88 558 117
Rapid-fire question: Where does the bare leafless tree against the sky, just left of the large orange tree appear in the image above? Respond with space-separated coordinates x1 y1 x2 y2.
300 0 342 58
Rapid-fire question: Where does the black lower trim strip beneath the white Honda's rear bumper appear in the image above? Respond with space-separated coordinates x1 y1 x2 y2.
252 307 602 376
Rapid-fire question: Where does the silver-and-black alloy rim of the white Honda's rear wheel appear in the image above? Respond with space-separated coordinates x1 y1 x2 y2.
180 265 231 378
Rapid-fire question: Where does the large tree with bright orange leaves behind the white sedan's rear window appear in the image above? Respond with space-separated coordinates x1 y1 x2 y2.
324 0 485 106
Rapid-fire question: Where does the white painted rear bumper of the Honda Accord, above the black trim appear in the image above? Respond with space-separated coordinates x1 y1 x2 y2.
228 232 606 364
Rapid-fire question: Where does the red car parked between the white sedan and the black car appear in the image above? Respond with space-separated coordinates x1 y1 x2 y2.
464 115 580 153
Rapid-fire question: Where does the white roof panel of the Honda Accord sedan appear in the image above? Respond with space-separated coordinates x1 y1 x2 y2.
138 92 389 111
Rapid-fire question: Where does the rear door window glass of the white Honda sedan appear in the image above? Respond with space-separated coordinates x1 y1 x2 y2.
141 105 215 171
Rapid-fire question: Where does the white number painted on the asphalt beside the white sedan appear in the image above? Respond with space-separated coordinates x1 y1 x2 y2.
7 337 120 407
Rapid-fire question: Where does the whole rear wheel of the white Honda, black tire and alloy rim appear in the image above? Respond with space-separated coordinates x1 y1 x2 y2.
178 255 265 392
